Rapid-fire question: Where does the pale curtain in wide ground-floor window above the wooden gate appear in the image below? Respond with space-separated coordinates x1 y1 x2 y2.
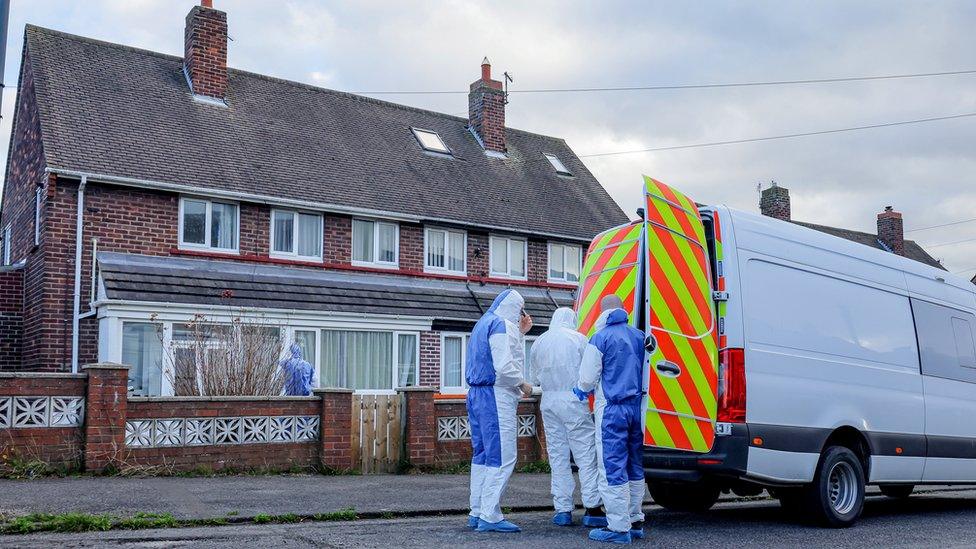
320 330 393 390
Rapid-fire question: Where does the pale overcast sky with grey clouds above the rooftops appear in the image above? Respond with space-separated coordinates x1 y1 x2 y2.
0 0 976 276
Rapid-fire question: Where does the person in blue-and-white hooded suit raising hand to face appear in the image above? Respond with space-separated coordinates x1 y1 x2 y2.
465 290 532 532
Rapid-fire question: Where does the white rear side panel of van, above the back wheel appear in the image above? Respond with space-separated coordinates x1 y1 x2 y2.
726 212 924 482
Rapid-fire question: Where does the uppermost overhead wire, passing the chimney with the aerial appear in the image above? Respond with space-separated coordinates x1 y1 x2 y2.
350 69 976 95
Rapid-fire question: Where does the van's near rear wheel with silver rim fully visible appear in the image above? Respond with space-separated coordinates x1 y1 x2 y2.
802 446 864 528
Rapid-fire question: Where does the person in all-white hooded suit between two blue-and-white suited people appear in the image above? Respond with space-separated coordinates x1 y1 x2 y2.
529 307 607 528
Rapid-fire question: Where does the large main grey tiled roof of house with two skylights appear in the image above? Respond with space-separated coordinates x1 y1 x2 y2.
25 25 628 240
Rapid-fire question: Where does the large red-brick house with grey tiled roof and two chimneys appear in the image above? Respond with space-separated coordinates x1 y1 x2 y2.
0 6 628 395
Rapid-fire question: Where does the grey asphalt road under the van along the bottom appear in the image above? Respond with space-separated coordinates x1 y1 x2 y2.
9 489 976 549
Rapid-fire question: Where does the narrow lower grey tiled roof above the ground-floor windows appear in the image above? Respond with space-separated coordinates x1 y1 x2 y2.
98 252 574 326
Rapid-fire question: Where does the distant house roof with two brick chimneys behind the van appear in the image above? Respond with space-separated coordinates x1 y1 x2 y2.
759 183 945 270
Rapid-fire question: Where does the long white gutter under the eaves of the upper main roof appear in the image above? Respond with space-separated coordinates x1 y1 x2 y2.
45 167 590 244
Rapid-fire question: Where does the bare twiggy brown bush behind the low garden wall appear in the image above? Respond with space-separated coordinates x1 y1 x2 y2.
164 315 285 396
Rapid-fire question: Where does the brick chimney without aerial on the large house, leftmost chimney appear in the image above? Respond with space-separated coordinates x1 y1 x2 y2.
183 0 227 100
